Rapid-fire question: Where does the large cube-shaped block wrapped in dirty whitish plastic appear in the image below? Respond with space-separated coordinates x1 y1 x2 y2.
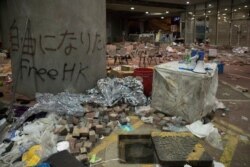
151 61 218 123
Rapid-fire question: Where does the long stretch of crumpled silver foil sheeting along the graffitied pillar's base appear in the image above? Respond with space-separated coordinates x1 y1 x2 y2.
13 77 147 129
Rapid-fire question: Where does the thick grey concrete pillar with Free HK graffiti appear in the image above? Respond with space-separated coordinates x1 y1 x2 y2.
5 0 106 96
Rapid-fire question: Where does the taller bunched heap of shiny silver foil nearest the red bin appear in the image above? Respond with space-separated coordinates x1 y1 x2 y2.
83 77 147 107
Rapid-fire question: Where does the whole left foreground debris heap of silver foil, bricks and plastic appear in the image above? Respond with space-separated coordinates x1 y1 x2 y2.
0 77 147 167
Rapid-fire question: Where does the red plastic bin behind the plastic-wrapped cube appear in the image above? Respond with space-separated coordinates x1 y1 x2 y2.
134 68 153 97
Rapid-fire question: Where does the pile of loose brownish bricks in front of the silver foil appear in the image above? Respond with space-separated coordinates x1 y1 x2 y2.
54 104 130 162
